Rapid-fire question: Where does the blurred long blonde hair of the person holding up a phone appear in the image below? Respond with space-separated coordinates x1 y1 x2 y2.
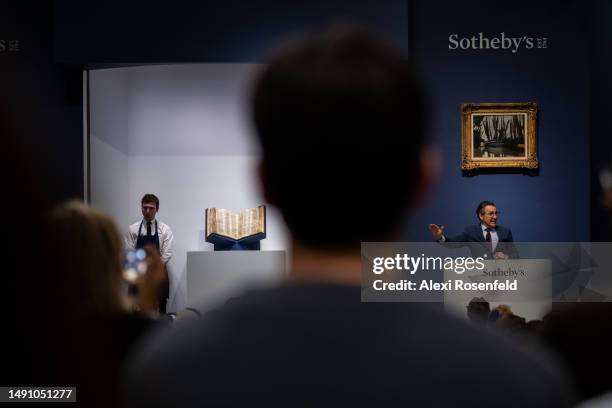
50 200 124 318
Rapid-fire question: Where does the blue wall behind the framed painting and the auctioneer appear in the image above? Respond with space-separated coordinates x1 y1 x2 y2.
406 0 590 241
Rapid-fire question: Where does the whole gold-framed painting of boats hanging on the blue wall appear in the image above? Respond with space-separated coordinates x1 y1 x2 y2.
461 102 539 170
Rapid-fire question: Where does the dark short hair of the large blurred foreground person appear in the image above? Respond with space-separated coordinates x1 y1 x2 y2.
252 25 427 248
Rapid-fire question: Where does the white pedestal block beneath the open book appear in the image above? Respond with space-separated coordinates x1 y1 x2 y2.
187 251 286 313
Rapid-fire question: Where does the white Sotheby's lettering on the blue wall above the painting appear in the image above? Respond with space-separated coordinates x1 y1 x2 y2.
448 31 548 54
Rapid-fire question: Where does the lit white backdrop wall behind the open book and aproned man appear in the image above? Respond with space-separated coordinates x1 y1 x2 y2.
90 64 288 311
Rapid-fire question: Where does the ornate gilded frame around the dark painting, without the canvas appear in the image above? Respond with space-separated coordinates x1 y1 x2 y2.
461 102 539 171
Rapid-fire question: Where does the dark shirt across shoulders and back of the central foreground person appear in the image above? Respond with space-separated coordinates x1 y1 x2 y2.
128 285 566 407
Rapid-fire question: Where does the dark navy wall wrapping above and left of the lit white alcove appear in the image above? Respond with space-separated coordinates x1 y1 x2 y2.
0 0 408 201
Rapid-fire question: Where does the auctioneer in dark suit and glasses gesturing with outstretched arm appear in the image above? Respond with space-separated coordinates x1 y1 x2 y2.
440 224 518 259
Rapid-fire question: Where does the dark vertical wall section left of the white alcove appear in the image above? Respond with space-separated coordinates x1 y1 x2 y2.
0 0 83 201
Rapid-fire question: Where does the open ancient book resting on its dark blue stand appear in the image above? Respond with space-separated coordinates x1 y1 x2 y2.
206 205 266 250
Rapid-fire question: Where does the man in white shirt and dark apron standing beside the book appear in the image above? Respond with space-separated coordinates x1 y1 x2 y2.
125 194 174 313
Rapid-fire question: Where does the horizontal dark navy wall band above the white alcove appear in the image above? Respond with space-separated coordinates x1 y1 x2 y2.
55 0 408 64
